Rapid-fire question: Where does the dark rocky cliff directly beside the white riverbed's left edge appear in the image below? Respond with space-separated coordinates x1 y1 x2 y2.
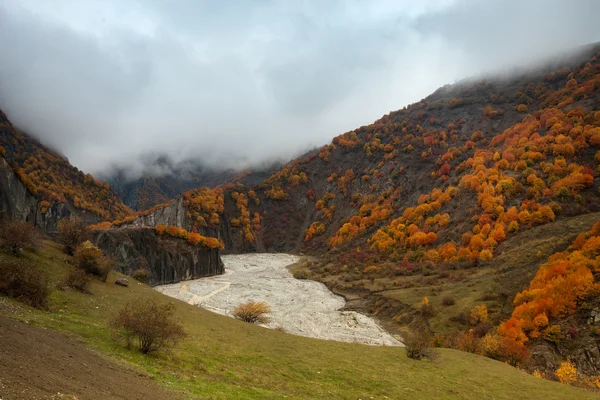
93 228 224 286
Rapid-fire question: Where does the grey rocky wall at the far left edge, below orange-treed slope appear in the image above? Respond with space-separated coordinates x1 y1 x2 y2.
0 157 98 233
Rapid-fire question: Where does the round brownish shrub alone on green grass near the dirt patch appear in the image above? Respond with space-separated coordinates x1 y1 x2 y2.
110 299 186 354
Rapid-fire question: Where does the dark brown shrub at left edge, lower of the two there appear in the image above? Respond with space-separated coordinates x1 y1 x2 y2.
0 259 50 309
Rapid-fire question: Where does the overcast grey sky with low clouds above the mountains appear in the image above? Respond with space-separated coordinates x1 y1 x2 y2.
0 0 600 177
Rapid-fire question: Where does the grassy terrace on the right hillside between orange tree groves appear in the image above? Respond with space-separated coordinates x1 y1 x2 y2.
360 213 600 334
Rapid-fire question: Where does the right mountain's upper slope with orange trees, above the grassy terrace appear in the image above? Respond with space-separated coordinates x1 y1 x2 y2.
135 43 600 262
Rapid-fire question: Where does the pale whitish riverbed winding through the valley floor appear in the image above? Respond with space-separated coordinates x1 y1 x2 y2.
156 254 402 346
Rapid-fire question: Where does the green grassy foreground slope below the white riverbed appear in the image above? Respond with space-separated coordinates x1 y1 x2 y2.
1 242 597 400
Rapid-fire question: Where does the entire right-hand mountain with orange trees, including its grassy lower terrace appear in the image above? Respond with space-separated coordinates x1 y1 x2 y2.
128 44 600 371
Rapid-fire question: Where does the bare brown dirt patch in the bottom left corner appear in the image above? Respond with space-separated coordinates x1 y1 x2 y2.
0 317 184 400
